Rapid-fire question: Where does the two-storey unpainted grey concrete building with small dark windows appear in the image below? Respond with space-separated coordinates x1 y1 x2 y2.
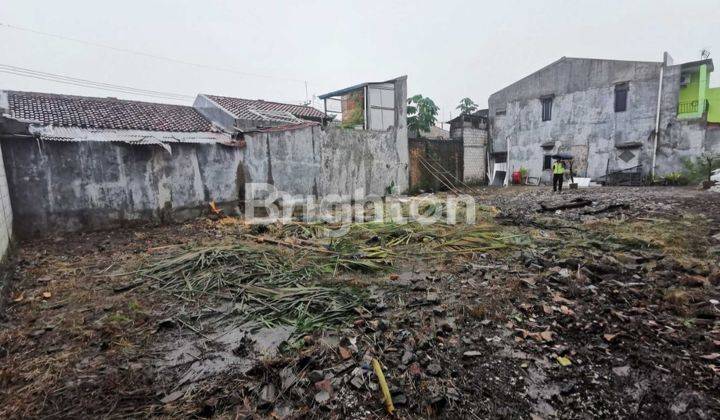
488 54 720 181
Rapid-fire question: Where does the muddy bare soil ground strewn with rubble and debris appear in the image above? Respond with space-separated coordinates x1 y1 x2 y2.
0 188 720 418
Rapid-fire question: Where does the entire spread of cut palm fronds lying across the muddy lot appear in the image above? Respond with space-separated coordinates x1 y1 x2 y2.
141 203 523 333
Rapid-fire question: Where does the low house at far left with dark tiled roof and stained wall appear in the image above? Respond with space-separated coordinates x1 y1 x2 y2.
0 91 242 236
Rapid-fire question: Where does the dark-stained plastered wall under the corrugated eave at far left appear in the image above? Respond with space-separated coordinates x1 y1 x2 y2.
3 138 243 237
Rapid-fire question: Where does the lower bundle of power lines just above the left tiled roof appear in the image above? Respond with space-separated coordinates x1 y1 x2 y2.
0 64 194 101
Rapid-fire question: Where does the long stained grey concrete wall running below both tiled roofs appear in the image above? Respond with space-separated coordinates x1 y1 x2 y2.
2 126 408 237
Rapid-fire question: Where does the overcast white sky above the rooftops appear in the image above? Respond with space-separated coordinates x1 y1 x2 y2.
0 0 720 125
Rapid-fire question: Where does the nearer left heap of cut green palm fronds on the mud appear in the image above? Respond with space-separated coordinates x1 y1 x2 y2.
140 244 385 334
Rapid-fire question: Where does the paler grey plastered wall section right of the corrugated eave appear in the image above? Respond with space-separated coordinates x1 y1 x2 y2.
245 126 408 197
